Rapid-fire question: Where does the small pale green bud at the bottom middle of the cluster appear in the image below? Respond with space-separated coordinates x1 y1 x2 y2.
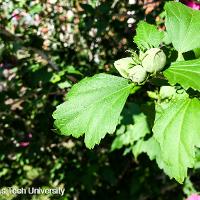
129 65 147 84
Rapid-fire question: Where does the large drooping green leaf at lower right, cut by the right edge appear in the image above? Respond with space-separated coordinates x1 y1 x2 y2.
153 97 200 183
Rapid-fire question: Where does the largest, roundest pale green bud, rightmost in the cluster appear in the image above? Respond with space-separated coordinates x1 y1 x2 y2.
142 48 166 73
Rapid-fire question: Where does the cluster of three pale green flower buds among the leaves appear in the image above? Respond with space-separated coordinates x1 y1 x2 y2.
114 48 166 84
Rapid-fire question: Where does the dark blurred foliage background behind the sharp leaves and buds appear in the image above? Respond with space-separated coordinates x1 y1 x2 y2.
0 0 200 200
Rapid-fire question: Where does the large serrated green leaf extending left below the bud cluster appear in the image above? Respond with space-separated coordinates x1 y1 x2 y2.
53 74 133 148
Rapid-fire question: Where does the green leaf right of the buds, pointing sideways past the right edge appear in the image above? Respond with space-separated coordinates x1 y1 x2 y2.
164 59 200 91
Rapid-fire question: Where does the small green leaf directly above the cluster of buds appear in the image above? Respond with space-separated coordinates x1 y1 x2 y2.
134 21 164 50
